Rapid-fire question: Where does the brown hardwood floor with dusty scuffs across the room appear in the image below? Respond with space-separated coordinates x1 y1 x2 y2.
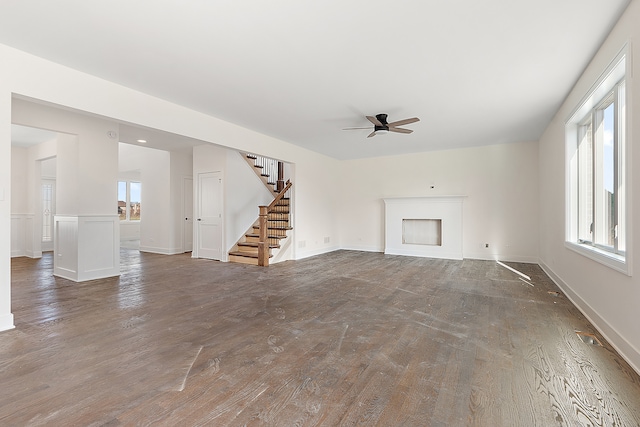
0 250 640 427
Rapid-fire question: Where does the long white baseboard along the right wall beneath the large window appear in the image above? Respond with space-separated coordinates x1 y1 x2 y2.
538 260 640 375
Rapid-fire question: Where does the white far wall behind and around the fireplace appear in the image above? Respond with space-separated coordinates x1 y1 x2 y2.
339 142 538 262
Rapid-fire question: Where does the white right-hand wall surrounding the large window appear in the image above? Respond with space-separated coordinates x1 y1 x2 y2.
539 2 640 372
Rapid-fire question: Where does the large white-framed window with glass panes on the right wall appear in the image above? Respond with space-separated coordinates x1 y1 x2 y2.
566 49 631 274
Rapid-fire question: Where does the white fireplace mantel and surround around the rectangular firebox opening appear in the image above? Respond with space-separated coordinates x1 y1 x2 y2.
383 196 466 259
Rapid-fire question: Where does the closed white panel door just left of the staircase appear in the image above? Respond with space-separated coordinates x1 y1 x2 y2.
197 172 222 260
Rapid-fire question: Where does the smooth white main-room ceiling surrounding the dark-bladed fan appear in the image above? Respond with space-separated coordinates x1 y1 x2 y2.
0 0 630 159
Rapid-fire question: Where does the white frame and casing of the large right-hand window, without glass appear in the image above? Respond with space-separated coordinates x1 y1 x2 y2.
565 45 632 276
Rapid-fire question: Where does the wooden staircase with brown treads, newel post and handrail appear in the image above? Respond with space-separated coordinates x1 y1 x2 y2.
229 154 293 266
